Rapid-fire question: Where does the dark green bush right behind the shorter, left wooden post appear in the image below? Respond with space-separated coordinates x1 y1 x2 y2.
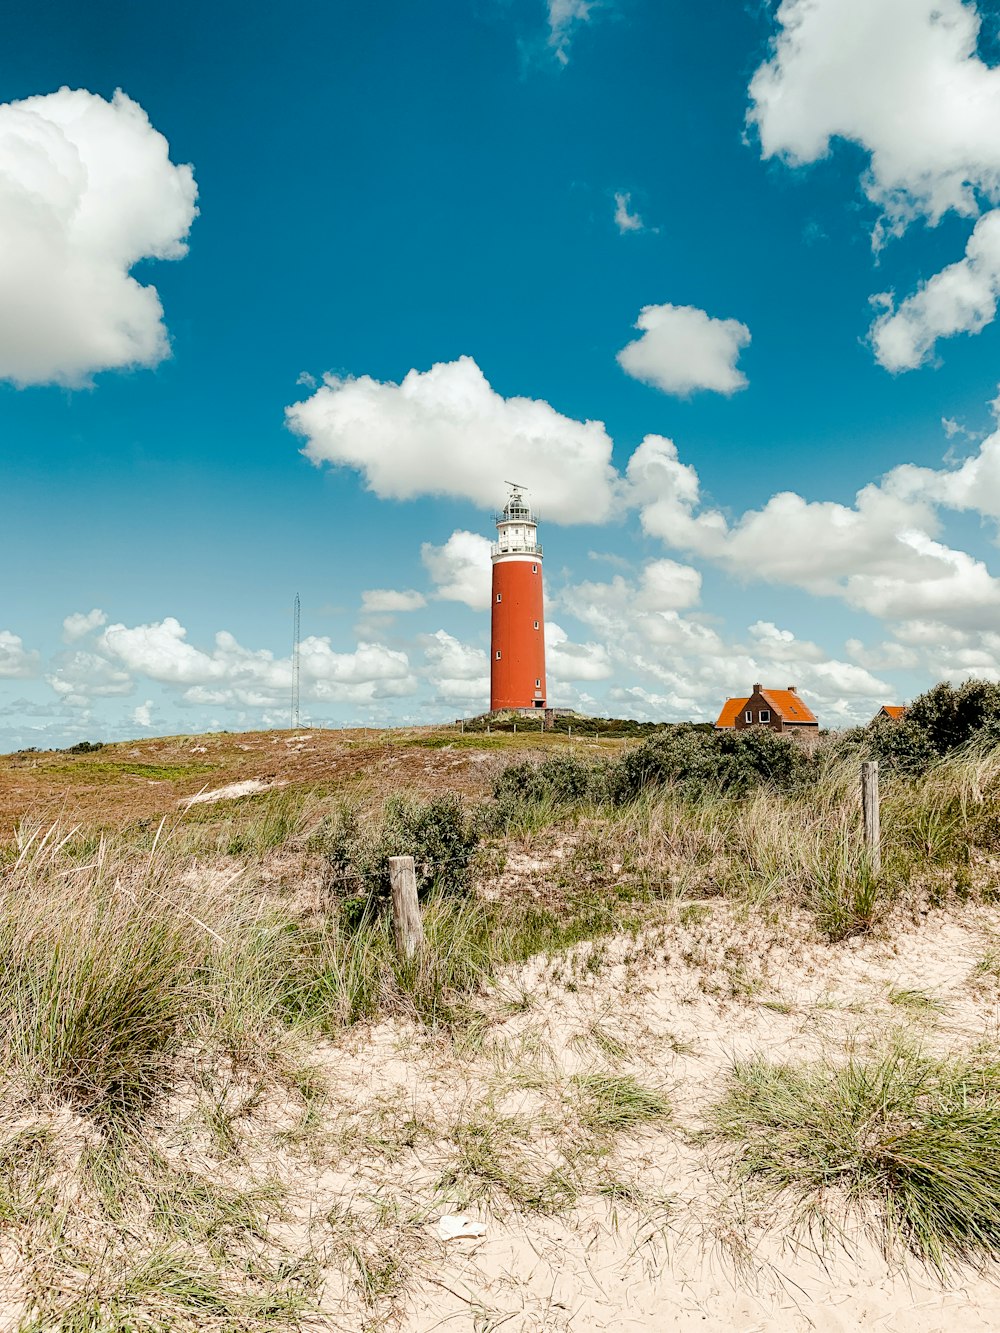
317 796 479 921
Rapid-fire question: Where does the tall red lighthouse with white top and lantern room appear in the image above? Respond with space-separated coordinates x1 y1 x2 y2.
489 481 545 712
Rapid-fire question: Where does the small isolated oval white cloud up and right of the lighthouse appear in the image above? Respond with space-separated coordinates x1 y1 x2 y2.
617 305 751 397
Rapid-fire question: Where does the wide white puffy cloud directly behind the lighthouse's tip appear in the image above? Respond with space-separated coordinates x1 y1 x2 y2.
285 356 617 523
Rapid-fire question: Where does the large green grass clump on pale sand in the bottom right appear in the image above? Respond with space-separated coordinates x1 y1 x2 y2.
712 1041 1000 1276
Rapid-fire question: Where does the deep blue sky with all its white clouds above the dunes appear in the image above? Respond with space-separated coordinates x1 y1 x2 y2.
0 0 1000 748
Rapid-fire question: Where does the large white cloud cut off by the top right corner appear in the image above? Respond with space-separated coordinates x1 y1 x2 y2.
748 0 1000 229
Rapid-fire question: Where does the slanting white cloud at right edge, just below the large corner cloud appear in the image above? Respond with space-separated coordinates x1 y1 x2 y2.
871 211 1000 372
